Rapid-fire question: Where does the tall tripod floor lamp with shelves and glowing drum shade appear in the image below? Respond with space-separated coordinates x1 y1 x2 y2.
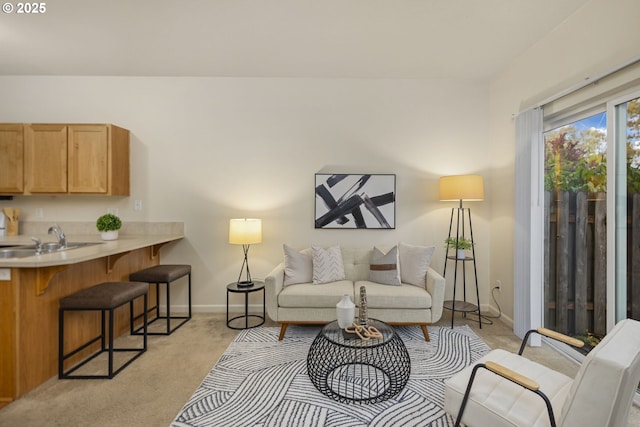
440 175 484 328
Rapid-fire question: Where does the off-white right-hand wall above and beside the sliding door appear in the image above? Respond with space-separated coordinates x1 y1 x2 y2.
490 0 640 319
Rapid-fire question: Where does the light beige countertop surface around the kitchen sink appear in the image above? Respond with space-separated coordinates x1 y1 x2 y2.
0 234 184 268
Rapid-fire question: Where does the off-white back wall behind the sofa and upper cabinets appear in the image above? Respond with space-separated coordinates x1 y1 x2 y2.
0 77 491 310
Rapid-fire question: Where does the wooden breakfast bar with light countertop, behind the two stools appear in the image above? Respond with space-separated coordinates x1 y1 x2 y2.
0 233 184 408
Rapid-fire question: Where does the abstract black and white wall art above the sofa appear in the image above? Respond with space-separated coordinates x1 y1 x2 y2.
315 173 396 229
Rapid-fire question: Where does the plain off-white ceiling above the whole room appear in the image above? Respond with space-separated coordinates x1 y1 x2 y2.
0 0 590 80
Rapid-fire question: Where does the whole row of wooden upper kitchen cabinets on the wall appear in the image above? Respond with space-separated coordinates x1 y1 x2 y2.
0 123 130 196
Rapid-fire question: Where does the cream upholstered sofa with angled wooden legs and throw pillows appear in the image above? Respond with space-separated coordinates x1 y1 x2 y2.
265 243 445 341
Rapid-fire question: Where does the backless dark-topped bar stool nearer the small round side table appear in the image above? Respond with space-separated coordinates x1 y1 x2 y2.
129 264 191 335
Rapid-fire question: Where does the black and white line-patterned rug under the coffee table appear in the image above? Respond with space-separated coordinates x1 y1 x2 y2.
171 326 490 427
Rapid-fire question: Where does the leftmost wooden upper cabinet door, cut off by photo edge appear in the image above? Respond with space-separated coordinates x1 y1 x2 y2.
0 124 24 194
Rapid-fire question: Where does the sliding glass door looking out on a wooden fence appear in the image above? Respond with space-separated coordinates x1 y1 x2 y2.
543 94 640 349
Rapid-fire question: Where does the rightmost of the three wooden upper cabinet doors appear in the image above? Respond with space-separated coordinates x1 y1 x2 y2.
68 125 110 194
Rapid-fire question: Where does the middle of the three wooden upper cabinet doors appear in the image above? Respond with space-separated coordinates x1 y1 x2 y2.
24 124 67 194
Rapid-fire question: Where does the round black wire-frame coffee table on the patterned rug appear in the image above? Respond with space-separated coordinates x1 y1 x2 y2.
307 319 411 403
